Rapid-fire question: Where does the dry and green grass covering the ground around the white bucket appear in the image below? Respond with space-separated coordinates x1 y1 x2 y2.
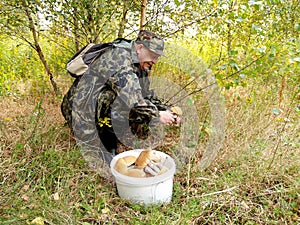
0 81 300 225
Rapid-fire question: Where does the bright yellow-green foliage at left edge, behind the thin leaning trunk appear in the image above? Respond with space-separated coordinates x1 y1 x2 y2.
0 35 70 95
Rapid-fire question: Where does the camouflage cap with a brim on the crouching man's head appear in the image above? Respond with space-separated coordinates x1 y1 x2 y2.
136 30 165 56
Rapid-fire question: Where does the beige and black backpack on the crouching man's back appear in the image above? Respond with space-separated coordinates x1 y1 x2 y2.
67 42 113 78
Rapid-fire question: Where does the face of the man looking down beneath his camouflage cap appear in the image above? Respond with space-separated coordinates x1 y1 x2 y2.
137 44 160 70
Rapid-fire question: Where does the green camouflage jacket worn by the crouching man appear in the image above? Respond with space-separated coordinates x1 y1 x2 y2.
62 38 167 137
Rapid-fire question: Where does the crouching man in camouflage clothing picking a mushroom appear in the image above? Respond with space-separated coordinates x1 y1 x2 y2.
62 30 180 161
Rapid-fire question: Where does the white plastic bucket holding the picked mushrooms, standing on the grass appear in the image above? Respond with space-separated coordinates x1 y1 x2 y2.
110 149 176 205
